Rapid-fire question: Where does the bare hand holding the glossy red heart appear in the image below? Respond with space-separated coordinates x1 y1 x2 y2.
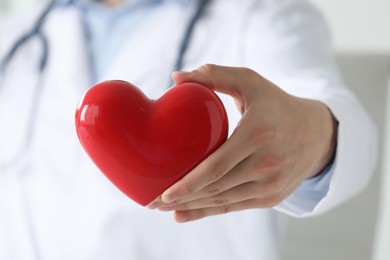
148 65 337 222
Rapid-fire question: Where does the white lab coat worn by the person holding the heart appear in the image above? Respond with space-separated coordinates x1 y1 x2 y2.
0 0 376 260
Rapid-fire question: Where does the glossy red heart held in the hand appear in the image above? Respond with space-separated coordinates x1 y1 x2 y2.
76 80 228 206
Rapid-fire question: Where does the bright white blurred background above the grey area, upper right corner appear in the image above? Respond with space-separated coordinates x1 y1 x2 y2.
311 0 390 54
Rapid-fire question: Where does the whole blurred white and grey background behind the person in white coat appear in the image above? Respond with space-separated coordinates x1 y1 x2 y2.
0 0 390 260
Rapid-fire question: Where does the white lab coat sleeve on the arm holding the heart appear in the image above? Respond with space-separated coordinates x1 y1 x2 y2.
243 0 378 217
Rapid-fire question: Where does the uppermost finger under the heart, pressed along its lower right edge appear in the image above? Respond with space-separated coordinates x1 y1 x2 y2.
161 128 256 203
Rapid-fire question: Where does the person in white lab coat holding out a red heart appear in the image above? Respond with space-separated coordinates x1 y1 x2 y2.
0 0 377 260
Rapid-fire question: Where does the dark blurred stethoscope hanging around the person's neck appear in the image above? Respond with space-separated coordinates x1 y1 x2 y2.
0 0 211 172
